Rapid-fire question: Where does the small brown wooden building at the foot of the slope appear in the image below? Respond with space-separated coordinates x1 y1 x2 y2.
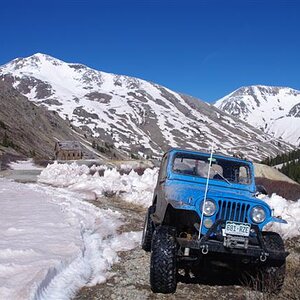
54 141 83 160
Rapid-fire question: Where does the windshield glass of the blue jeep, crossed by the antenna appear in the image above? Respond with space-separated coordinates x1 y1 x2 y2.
172 153 251 184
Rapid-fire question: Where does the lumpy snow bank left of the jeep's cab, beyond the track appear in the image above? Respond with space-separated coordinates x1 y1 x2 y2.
38 163 158 207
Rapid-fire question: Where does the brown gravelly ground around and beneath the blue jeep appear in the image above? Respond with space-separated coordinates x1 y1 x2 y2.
74 197 300 300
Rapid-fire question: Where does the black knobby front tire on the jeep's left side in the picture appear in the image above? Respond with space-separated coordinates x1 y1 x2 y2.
150 226 177 294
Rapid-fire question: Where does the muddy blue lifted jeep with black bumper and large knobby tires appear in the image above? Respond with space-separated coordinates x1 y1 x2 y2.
142 149 288 293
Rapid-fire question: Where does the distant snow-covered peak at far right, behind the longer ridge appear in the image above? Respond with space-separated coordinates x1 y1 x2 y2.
215 85 300 146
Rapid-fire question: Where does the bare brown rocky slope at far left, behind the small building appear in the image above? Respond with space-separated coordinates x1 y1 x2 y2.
0 80 122 158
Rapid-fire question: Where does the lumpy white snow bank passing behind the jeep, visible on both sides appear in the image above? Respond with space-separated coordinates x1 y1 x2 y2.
39 163 300 238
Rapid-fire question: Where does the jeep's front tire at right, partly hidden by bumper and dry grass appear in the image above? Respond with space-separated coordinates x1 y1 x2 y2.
257 232 285 294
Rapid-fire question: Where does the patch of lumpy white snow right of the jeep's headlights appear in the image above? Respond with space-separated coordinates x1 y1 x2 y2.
263 194 300 239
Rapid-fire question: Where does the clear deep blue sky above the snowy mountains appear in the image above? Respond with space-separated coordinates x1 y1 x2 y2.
0 0 300 102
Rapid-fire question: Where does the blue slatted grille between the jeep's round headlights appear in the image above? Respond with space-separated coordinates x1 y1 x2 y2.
217 200 250 222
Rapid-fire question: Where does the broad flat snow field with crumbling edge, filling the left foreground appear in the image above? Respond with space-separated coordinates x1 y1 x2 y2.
0 179 141 300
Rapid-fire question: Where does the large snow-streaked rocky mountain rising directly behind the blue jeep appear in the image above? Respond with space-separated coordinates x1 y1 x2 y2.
0 53 292 160
